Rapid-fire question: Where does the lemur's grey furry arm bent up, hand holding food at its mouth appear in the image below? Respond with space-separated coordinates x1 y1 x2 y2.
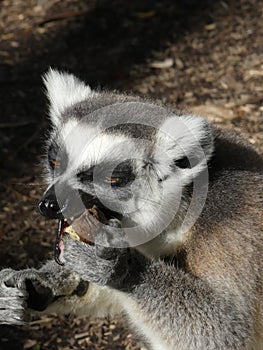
63 239 253 350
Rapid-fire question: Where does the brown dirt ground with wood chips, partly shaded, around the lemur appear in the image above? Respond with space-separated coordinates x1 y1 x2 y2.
0 0 263 350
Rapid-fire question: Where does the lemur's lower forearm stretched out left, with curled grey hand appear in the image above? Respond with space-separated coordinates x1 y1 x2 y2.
0 261 121 325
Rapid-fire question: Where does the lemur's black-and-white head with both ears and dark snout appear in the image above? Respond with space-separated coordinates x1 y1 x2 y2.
39 70 213 253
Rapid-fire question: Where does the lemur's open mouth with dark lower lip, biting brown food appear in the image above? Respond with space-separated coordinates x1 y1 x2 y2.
55 205 121 265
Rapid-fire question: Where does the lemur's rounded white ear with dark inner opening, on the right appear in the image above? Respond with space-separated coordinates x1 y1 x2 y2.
155 115 214 182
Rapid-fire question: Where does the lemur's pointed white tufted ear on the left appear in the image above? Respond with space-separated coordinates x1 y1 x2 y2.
43 68 92 125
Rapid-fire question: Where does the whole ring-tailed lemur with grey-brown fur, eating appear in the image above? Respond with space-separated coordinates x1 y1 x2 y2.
0 70 263 350
